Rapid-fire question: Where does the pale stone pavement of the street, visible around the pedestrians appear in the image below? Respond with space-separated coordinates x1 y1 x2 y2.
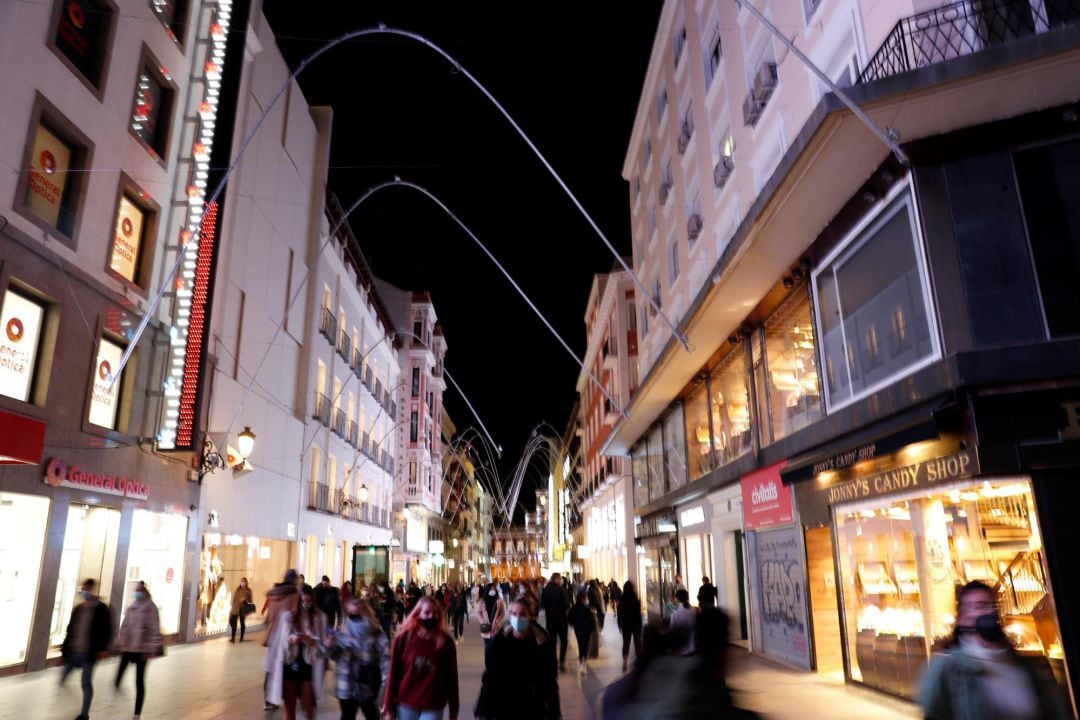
0 614 918 720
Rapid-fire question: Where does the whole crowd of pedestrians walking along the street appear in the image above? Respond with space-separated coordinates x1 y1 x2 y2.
52 570 1071 720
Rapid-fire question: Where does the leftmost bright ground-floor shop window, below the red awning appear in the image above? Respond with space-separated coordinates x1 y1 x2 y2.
0 492 49 667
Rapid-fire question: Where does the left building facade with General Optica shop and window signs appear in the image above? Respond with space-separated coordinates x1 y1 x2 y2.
0 0 235 674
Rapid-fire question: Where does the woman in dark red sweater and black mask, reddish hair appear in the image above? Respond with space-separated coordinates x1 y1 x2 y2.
382 596 458 720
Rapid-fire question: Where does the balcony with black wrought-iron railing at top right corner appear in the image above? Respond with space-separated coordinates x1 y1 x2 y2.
859 0 1080 83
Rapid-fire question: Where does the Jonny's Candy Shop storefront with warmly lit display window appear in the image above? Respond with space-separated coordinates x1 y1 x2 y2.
796 437 1066 698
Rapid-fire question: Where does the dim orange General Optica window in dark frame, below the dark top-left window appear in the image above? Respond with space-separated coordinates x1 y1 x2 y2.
18 113 90 240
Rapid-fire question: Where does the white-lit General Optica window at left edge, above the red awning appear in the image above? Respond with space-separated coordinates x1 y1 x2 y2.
0 288 45 403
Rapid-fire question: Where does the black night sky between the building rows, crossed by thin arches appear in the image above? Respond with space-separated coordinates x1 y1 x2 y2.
265 0 662 492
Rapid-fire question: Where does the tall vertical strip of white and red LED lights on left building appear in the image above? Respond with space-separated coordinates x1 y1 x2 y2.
158 0 232 449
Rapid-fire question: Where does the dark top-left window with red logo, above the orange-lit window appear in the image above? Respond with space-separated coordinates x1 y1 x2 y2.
51 0 116 91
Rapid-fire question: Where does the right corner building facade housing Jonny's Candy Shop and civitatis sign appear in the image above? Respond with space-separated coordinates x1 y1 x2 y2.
604 0 1080 701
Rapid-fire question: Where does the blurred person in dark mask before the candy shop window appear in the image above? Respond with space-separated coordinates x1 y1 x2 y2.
919 581 1072 720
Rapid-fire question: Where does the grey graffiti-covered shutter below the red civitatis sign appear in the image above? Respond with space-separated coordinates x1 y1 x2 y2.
750 528 810 670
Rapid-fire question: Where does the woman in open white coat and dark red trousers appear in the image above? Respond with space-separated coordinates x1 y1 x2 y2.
264 588 326 720
